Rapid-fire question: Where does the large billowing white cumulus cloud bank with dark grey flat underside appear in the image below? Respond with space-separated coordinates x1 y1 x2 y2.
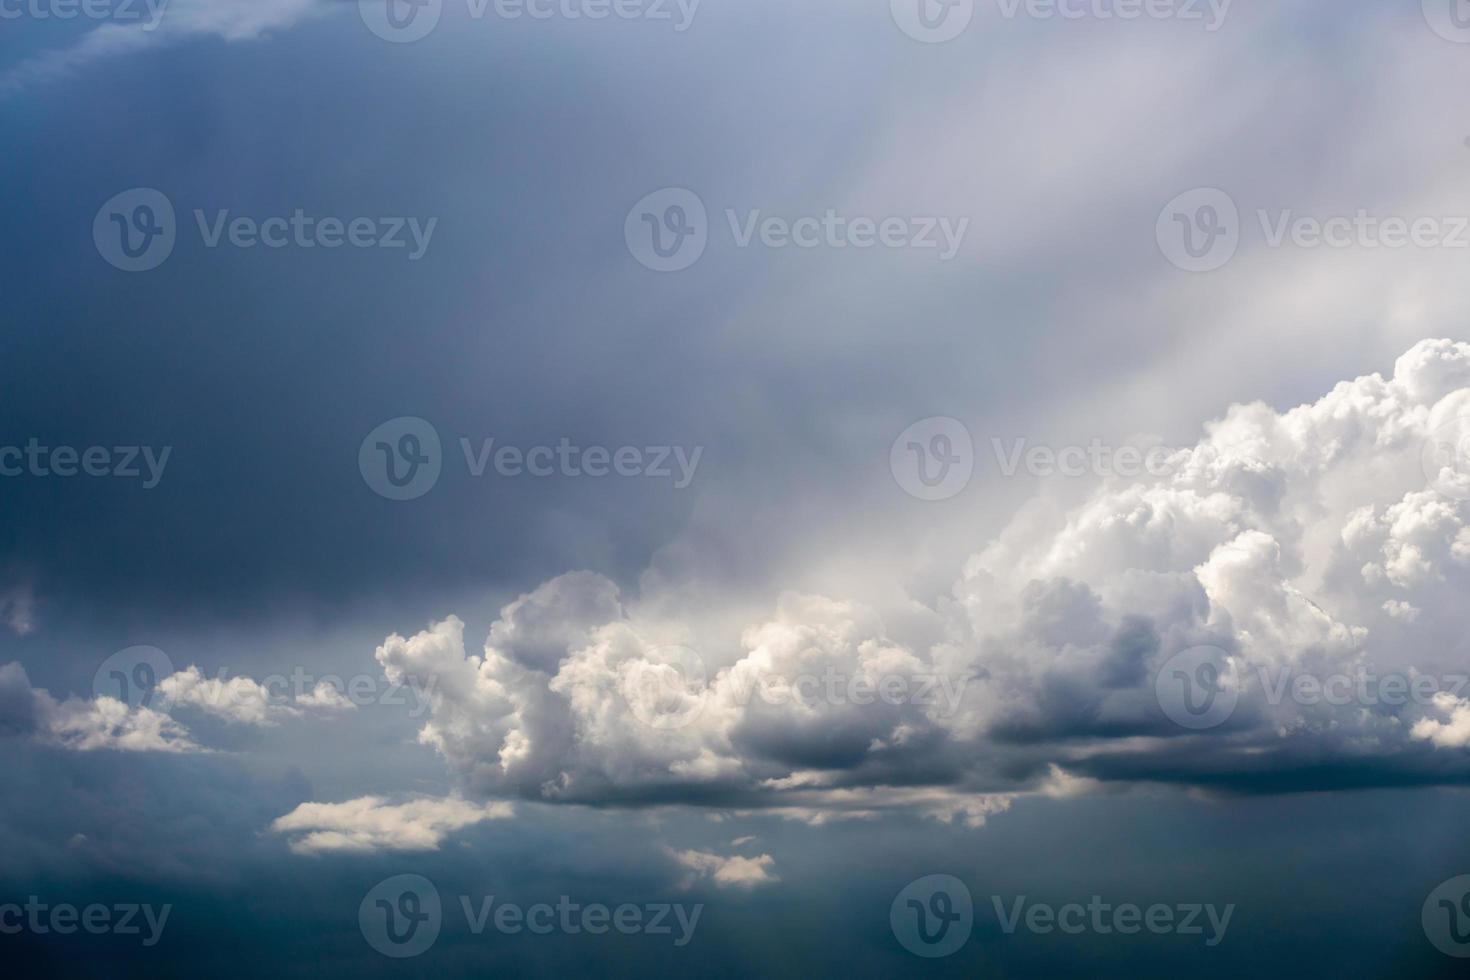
364 341 1470 824
